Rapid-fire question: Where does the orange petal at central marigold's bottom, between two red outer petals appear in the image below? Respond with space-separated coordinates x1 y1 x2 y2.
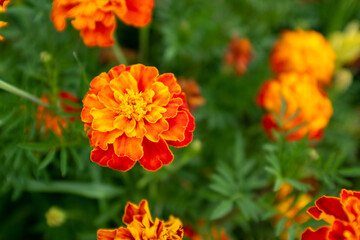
114 134 144 161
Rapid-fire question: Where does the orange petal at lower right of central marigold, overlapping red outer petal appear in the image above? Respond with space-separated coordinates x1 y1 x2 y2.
161 111 189 142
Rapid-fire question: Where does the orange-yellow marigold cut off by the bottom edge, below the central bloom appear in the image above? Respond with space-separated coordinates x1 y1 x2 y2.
97 200 184 240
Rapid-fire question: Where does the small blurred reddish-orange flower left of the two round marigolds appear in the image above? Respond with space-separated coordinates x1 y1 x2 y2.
225 36 252 75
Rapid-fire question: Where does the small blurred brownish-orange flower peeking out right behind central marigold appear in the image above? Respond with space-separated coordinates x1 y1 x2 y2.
179 78 205 112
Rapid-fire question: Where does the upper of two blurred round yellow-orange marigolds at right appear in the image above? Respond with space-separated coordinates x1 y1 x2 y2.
271 30 335 84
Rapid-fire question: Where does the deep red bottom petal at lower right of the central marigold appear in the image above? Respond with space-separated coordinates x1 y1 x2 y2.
139 138 174 171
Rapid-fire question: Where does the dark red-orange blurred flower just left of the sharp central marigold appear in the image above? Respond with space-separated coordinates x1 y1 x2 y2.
36 91 81 137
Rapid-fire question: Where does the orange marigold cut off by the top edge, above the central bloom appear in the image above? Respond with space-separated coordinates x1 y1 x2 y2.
51 0 154 47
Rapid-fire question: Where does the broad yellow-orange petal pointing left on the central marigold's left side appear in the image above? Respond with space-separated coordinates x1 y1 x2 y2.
90 108 117 132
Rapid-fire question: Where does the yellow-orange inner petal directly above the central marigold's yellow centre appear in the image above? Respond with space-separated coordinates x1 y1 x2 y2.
110 72 138 96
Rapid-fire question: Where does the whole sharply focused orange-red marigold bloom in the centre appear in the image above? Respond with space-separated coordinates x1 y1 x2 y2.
81 64 195 171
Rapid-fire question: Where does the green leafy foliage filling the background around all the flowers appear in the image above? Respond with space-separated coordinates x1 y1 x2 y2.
0 0 360 240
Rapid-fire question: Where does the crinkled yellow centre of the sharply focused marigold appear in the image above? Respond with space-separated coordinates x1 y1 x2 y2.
119 89 154 121
